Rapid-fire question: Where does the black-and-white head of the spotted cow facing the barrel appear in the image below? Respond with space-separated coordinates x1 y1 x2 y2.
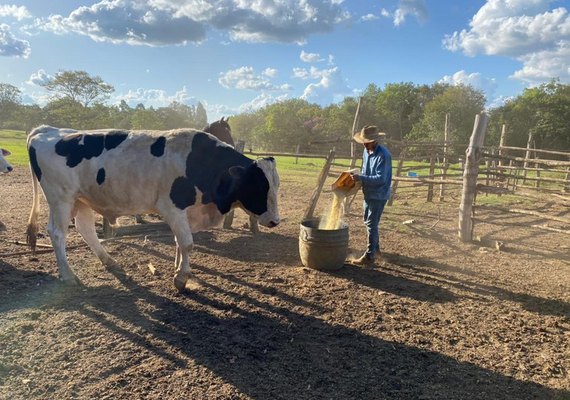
223 157 280 228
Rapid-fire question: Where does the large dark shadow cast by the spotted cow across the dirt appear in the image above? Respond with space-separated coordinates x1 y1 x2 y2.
52 275 568 399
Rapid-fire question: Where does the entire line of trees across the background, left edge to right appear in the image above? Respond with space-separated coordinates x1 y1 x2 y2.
0 71 570 151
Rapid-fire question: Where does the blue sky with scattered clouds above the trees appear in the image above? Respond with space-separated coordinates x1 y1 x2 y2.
0 0 570 121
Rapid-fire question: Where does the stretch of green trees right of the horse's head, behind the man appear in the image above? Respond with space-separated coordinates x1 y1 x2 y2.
231 80 570 151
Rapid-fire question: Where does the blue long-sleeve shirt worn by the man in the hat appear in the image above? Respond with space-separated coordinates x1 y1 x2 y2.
360 144 392 200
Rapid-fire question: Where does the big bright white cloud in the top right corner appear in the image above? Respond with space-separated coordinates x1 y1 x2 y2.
443 0 570 82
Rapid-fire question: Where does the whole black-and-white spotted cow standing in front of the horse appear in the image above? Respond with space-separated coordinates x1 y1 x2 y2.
27 126 280 290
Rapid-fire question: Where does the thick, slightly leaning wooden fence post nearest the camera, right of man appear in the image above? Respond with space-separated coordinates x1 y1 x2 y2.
458 112 488 242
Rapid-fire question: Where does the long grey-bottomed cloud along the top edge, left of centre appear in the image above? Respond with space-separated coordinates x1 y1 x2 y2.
32 0 351 46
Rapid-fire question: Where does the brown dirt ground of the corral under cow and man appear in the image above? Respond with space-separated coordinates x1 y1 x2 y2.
0 167 570 400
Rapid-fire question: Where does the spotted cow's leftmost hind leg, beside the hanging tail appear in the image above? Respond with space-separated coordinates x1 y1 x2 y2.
48 200 80 284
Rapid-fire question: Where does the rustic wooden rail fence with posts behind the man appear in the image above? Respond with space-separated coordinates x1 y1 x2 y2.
242 113 570 242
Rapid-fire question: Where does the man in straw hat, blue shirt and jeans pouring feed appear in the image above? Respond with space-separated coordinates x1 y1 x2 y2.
352 125 392 265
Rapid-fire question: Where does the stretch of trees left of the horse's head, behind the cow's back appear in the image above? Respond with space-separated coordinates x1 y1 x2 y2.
0 71 208 131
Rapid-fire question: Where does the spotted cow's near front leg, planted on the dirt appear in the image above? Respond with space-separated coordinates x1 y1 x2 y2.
163 212 194 291
